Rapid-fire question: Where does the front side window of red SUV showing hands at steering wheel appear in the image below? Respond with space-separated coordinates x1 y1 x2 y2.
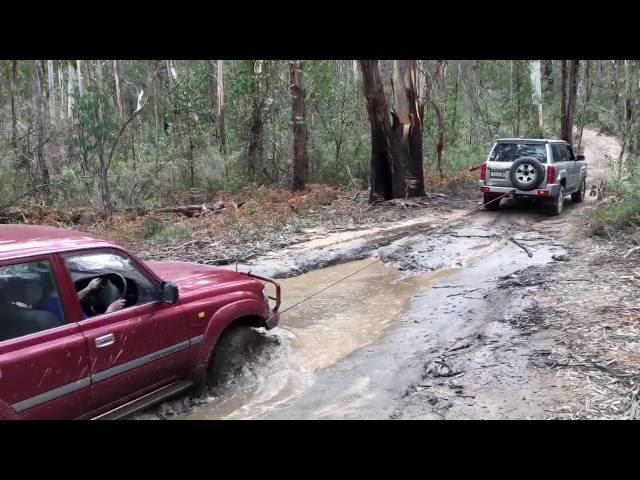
65 252 159 318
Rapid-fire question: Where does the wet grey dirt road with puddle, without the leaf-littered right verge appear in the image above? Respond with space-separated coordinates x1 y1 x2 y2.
141 128 607 419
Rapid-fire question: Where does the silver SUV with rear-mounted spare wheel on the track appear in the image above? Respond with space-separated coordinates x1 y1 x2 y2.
480 138 587 215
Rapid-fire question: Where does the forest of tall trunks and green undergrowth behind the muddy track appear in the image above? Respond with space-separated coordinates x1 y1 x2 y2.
0 60 640 229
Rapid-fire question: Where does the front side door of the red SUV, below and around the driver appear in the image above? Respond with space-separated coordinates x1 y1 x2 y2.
59 249 189 413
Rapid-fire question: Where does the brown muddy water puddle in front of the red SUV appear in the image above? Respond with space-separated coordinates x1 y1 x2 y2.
182 259 459 419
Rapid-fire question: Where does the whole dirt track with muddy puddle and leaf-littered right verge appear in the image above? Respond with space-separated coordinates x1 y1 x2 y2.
136 131 640 419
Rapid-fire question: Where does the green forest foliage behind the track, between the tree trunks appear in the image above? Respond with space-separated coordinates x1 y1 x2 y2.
0 60 640 218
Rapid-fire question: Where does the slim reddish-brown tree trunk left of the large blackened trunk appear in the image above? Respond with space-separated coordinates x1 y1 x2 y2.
289 60 309 191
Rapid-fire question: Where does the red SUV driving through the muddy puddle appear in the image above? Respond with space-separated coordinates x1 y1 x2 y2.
0 225 280 419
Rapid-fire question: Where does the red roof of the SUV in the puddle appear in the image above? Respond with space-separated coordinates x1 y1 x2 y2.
0 225 114 261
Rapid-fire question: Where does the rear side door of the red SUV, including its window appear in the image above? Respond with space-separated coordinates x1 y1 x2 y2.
0 256 91 420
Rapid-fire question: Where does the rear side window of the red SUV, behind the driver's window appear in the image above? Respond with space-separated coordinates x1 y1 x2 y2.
0 261 65 342
